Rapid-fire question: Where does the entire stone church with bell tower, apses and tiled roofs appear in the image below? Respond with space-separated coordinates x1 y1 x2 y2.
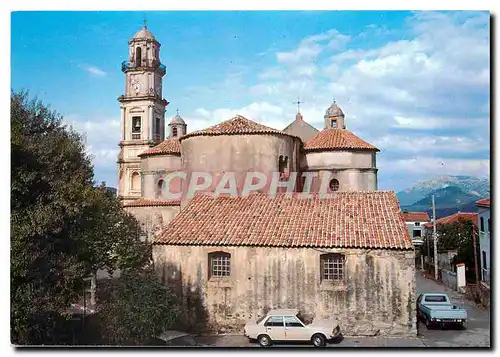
117 26 416 335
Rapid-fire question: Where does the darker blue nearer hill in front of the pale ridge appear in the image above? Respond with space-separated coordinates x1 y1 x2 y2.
401 186 478 218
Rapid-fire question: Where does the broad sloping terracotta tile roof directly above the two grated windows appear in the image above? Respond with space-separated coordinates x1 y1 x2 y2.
153 191 413 249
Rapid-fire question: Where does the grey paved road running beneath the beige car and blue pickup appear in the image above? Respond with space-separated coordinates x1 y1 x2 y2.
193 272 490 348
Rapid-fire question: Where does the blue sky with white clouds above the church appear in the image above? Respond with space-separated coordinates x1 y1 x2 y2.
11 11 490 191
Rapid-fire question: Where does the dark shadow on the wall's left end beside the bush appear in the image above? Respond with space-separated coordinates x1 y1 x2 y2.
159 263 212 334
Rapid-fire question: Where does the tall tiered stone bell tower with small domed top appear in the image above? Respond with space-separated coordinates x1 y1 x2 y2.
118 23 168 203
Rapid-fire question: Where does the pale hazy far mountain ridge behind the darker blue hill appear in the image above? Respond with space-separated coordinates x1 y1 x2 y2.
397 175 490 206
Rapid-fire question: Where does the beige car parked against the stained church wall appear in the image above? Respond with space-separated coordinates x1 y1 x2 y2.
245 309 340 347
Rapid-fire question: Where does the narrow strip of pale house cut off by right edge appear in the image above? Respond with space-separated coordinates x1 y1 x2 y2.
476 198 491 284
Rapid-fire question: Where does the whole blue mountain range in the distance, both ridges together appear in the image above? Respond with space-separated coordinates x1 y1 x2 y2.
397 175 491 218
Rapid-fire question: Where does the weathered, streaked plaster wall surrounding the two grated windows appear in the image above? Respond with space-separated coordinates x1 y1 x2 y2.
153 245 416 336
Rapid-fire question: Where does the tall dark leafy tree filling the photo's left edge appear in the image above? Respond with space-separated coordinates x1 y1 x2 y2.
11 92 180 345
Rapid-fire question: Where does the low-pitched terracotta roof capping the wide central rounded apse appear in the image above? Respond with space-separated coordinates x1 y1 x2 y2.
181 115 297 140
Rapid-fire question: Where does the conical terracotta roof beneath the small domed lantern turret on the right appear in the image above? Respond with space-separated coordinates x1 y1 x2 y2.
304 128 380 151
